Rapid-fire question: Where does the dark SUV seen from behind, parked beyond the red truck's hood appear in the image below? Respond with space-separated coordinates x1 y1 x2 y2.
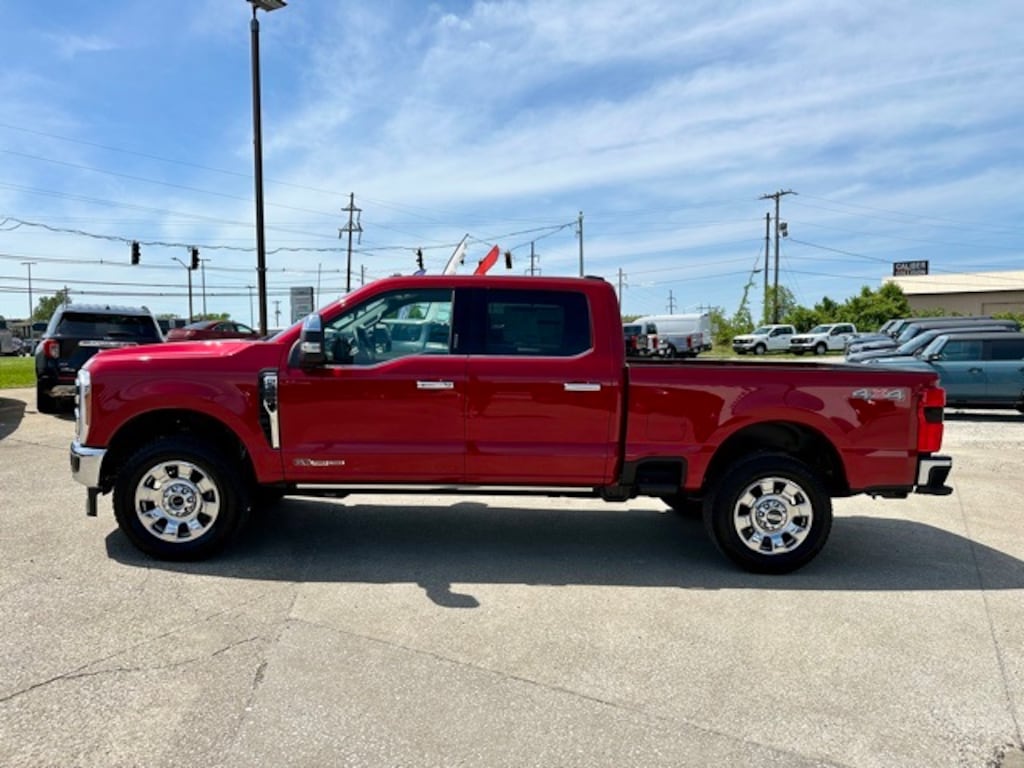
35 304 164 414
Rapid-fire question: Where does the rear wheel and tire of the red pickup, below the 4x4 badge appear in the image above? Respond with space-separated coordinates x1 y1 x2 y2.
703 454 833 573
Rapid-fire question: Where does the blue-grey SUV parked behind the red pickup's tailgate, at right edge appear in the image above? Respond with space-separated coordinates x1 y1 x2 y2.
882 331 1024 413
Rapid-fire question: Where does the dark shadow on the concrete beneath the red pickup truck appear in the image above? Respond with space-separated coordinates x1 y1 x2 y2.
106 499 1024 607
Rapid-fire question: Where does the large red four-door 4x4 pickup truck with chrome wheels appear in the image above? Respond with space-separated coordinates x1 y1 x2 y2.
71 275 952 572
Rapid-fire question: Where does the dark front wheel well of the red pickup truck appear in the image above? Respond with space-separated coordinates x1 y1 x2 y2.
101 410 255 490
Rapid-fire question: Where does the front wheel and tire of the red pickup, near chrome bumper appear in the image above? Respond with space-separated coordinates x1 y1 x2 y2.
114 437 250 561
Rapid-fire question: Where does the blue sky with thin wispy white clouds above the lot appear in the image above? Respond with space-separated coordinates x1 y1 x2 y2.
0 0 1024 327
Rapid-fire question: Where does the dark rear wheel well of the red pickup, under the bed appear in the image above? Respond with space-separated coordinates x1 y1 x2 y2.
701 422 850 497
